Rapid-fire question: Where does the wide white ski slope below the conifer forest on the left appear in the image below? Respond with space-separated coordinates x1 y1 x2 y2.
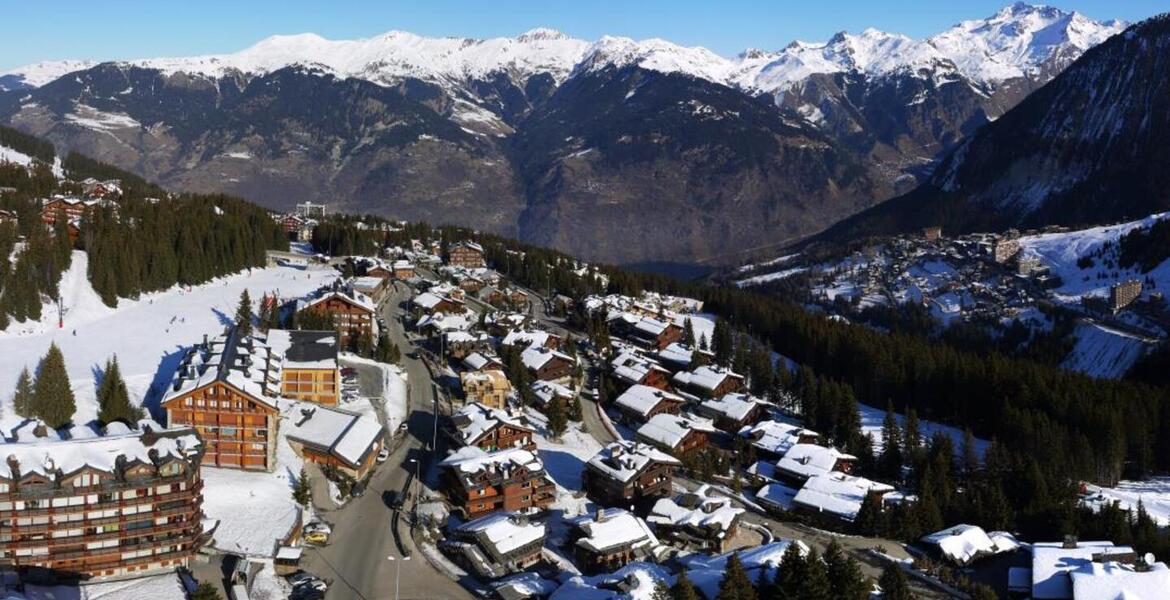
0 251 337 430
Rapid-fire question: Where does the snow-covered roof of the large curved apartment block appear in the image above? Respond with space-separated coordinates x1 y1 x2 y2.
0 427 201 478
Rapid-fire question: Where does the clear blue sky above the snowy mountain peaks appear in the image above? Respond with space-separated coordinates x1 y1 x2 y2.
0 0 1168 70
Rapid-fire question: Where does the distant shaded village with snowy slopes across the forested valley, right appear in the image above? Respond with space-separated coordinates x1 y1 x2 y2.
730 215 1170 378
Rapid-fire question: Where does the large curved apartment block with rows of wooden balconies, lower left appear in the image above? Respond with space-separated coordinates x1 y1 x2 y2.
0 421 207 579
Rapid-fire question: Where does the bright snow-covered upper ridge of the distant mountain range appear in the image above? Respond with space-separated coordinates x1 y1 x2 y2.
0 5 1124 94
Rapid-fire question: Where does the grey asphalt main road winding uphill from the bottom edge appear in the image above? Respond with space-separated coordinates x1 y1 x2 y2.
303 280 474 600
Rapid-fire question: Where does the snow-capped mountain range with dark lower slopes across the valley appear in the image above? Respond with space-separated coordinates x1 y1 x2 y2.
0 5 1121 262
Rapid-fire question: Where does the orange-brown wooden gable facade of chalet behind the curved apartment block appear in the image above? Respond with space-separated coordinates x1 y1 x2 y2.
163 380 280 471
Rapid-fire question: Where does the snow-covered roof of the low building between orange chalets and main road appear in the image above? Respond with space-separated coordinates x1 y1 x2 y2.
282 402 383 467
